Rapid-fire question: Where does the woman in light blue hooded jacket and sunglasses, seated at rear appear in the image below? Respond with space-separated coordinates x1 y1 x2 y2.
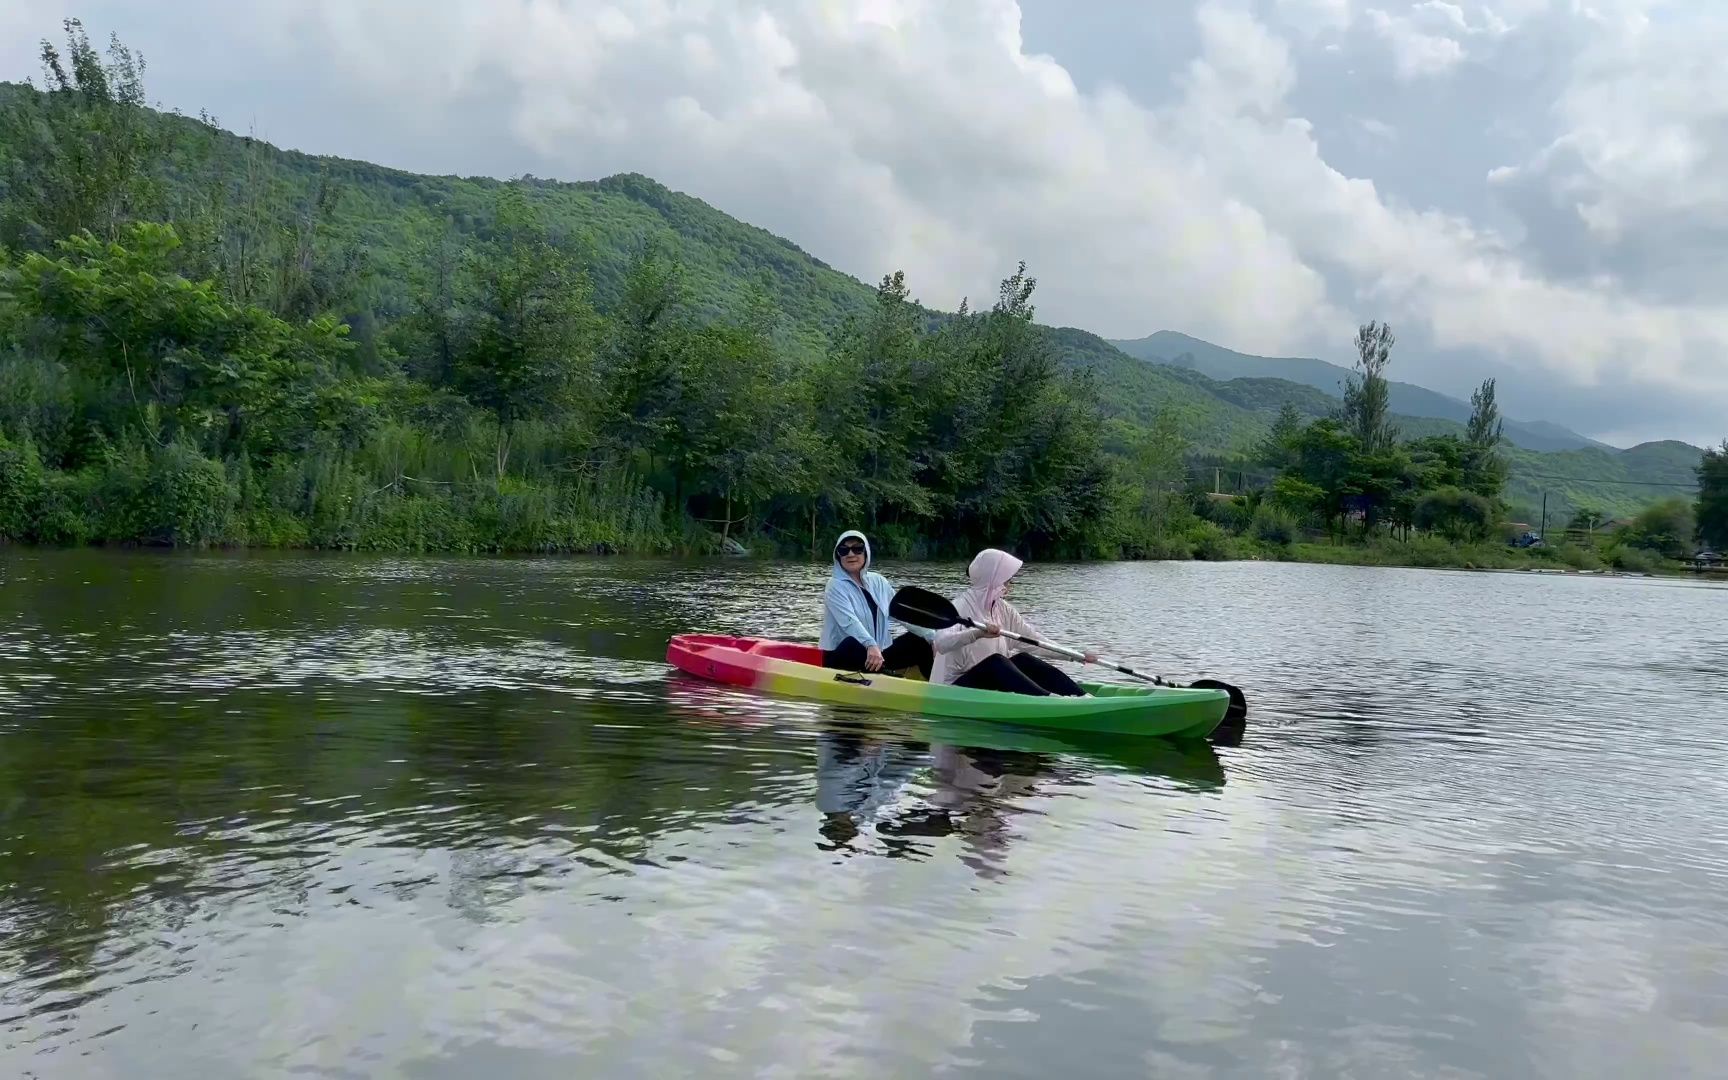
821 529 935 679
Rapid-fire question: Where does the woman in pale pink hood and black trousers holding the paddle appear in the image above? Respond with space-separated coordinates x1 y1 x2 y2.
930 548 1097 698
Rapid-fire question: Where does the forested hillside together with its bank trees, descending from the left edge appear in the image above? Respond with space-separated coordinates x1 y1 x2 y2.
0 24 1697 555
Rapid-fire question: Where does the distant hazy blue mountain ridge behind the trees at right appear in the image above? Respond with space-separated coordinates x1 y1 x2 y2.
1109 330 1619 451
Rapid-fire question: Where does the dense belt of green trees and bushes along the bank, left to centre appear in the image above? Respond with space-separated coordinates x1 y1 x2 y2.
0 213 1111 551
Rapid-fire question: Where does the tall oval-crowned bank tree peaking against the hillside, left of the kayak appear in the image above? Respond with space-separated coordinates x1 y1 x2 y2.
456 185 600 479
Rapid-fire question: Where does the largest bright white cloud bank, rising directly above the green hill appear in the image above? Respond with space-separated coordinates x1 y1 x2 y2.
259 0 1337 347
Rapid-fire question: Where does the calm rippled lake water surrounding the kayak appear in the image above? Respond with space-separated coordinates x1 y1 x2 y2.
0 550 1728 1080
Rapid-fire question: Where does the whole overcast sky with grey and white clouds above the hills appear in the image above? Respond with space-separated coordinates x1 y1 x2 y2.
0 0 1728 444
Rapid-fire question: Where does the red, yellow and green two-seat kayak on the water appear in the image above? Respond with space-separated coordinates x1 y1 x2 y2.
665 634 1230 740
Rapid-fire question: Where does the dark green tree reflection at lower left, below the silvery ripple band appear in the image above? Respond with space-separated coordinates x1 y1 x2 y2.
0 684 802 1018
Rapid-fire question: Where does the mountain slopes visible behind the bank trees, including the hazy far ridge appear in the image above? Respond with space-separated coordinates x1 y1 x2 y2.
0 73 1702 518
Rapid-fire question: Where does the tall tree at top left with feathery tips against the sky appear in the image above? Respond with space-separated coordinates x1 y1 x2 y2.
0 19 168 251
